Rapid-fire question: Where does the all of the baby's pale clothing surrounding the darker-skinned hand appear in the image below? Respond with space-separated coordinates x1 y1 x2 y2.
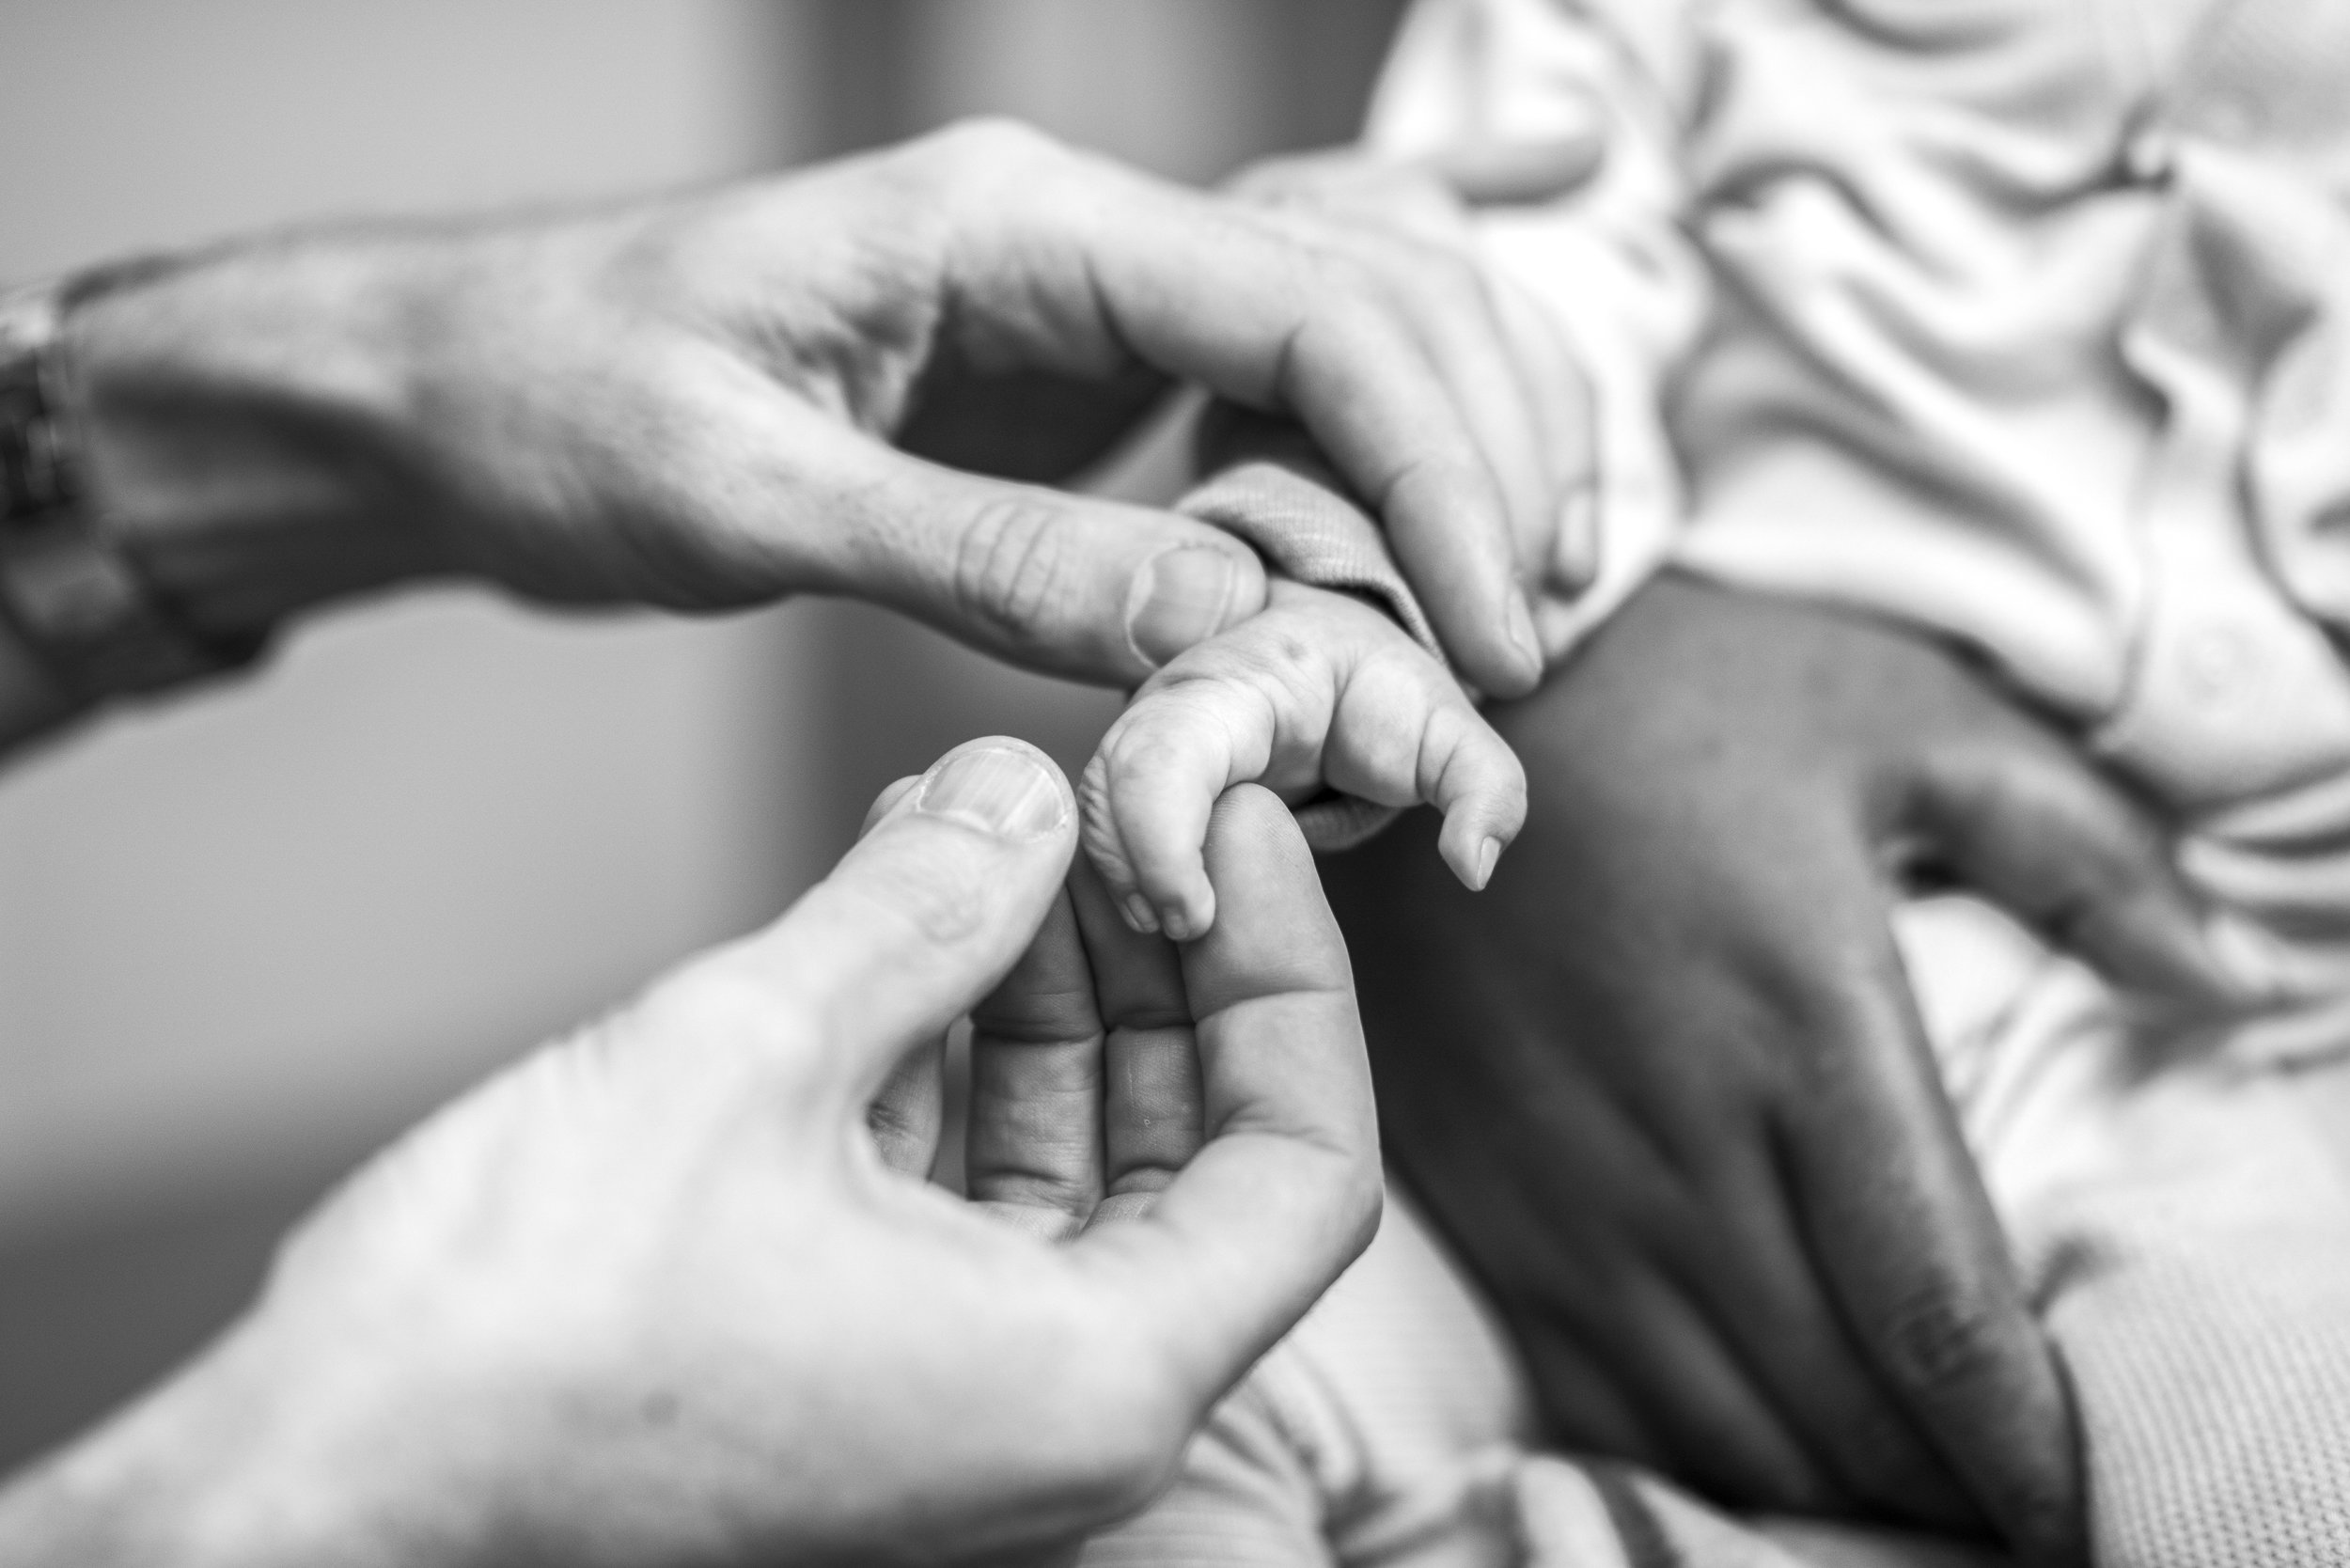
1086 0 2350 1568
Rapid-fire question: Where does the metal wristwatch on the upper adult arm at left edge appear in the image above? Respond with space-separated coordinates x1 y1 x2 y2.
0 280 266 703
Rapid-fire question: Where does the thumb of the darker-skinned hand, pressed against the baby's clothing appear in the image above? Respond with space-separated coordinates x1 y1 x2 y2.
1913 722 2256 1011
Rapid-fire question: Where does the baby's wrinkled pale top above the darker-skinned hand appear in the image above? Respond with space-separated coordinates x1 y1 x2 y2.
1372 0 2350 1056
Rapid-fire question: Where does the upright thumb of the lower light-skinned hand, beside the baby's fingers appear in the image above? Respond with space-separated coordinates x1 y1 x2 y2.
656 736 1076 1112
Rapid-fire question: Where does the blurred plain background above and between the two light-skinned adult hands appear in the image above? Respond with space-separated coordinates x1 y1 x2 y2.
0 0 1401 1469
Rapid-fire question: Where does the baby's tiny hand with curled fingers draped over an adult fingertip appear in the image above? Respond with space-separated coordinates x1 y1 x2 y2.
1079 581 1526 940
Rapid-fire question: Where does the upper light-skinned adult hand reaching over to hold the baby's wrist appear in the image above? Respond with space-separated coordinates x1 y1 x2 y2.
69 125 1589 694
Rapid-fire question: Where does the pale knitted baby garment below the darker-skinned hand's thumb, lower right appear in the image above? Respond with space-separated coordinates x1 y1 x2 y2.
1904 901 2350 1568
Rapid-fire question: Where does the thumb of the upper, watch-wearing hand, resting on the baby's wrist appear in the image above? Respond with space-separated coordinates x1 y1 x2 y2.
844 442 1264 686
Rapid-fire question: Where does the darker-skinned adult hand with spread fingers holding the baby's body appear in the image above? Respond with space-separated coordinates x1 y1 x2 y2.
1330 578 2228 1559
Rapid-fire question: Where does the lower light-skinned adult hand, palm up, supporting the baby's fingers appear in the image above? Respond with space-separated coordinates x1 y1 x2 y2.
0 741 1380 1568
